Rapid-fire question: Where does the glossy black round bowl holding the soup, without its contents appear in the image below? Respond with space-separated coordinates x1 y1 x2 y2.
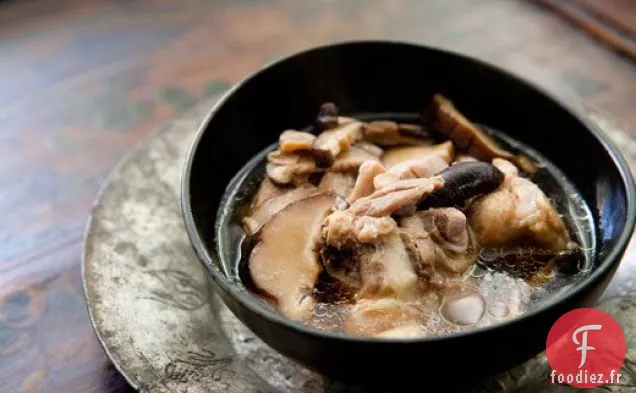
182 42 636 386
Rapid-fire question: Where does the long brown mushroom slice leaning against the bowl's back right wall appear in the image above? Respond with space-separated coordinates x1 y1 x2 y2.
422 94 536 173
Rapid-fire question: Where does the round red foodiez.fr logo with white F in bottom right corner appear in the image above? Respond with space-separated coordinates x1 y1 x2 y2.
546 308 627 388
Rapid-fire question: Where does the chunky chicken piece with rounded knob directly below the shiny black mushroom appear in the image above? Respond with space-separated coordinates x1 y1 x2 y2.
400 208 476 278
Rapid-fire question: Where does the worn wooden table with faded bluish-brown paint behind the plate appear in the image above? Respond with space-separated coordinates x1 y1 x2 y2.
0 0 636 393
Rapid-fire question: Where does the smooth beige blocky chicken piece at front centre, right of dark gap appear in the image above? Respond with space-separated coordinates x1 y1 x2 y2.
358 233 418 299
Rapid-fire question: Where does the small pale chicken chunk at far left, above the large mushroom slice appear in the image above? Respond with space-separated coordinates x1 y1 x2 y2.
265 150 321 185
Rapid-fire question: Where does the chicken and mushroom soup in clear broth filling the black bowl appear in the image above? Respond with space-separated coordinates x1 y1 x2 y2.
232 95 595 338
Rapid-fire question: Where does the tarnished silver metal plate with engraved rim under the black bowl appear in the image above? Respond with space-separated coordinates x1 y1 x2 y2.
83 102 636 393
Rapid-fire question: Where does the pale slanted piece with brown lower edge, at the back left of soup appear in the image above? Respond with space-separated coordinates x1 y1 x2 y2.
312 121 363 168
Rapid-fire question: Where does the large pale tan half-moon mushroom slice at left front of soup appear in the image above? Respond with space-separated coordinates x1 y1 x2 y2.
249 194 335 321
